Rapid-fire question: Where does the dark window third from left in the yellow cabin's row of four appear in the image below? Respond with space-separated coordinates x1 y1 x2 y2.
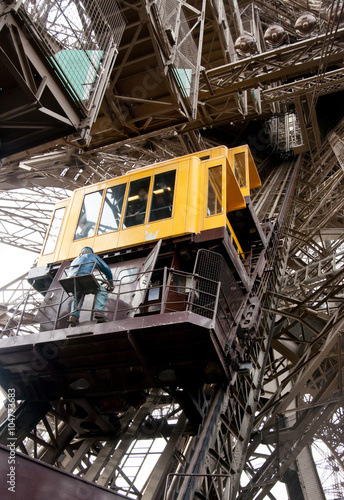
123 177 150 228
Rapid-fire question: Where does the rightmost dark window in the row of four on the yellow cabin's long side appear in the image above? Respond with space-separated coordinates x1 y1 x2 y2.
149 170 176 222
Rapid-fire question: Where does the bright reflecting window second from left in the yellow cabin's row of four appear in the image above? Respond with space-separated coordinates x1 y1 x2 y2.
98 184 126 234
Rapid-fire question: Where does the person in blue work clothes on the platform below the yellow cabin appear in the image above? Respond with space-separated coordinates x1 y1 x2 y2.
68 247 114 326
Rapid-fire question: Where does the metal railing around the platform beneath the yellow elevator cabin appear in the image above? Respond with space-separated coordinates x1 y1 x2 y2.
0 267 234 339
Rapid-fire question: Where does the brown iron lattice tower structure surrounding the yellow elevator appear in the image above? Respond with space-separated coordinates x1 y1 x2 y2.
0 0 344 500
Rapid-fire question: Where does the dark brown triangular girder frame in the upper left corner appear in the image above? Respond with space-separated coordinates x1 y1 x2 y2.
0 3 80 158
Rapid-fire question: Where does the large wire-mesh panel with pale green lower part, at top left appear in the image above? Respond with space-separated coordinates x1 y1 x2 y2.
23 0 125 109
